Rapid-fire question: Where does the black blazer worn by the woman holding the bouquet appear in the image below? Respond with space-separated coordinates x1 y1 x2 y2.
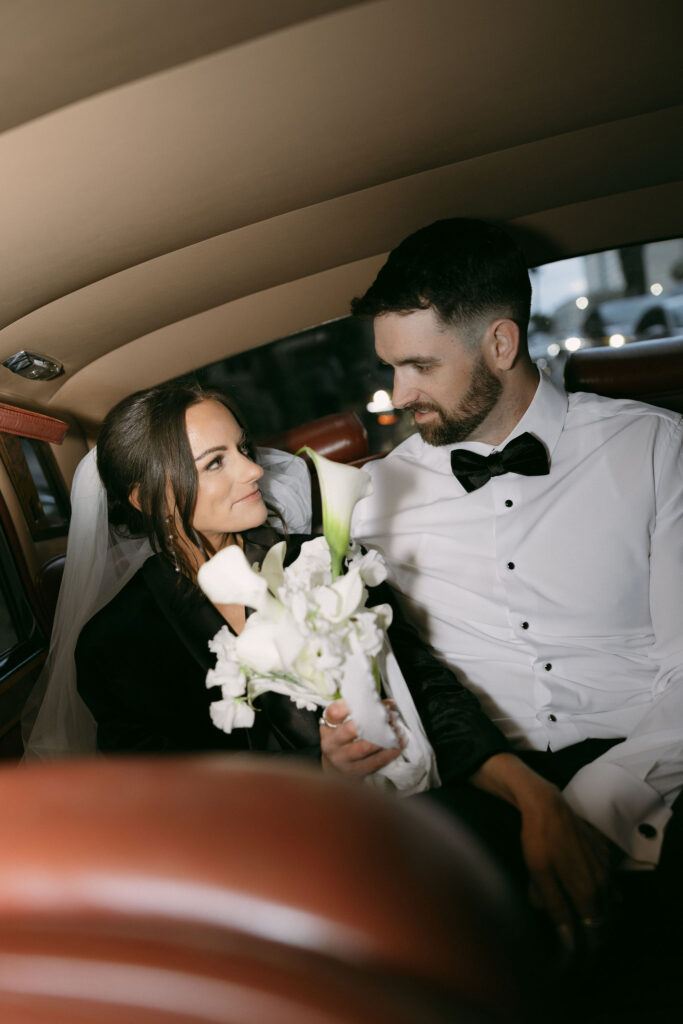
76 529 508 782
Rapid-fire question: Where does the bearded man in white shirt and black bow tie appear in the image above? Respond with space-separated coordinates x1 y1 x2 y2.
324 219 683 934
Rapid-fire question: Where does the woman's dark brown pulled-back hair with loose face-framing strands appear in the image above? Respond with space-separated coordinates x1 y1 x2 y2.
97 383 253 579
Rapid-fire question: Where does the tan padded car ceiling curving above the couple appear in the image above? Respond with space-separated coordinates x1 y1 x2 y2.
0 0 683 430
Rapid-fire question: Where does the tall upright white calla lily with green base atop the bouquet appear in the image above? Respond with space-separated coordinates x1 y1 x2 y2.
297 446 373 580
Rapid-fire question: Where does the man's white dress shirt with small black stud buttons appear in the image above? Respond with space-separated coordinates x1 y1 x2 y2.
352 375 683 864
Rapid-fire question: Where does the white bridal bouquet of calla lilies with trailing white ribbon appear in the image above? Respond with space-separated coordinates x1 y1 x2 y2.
198 449 433 795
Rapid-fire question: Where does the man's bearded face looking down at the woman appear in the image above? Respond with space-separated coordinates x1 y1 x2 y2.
375 308 502 444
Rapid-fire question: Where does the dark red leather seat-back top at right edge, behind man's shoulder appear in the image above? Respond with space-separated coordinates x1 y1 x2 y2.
564 338 683 413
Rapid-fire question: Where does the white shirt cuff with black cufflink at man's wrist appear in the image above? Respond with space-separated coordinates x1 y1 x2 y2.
563 762 671 865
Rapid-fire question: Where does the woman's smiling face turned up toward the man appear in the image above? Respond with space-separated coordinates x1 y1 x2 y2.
185 398 267 550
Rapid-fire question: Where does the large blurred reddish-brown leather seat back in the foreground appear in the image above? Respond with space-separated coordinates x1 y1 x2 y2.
0 757 531 1024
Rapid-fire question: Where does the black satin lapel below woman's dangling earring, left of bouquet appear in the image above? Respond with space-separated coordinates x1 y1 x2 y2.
142 555 226 673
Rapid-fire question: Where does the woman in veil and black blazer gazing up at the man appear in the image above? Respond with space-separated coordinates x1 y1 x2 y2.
27 383 499 777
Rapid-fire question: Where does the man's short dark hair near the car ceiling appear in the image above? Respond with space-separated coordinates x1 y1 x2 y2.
351 217 531 341
